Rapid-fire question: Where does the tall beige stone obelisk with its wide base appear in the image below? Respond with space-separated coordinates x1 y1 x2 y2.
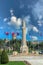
20 21 28 54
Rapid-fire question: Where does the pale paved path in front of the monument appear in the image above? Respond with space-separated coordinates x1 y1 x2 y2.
9 56 43 65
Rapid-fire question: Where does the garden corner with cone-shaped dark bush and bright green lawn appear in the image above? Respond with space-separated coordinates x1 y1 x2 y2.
0 49 31 65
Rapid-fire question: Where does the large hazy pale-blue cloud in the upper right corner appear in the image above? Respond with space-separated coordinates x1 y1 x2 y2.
33 0 43 19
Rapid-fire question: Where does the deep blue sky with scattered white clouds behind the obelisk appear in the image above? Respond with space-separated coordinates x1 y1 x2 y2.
0 0 43 40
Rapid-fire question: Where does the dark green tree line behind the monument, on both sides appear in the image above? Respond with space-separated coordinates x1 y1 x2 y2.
0 39 43 52
